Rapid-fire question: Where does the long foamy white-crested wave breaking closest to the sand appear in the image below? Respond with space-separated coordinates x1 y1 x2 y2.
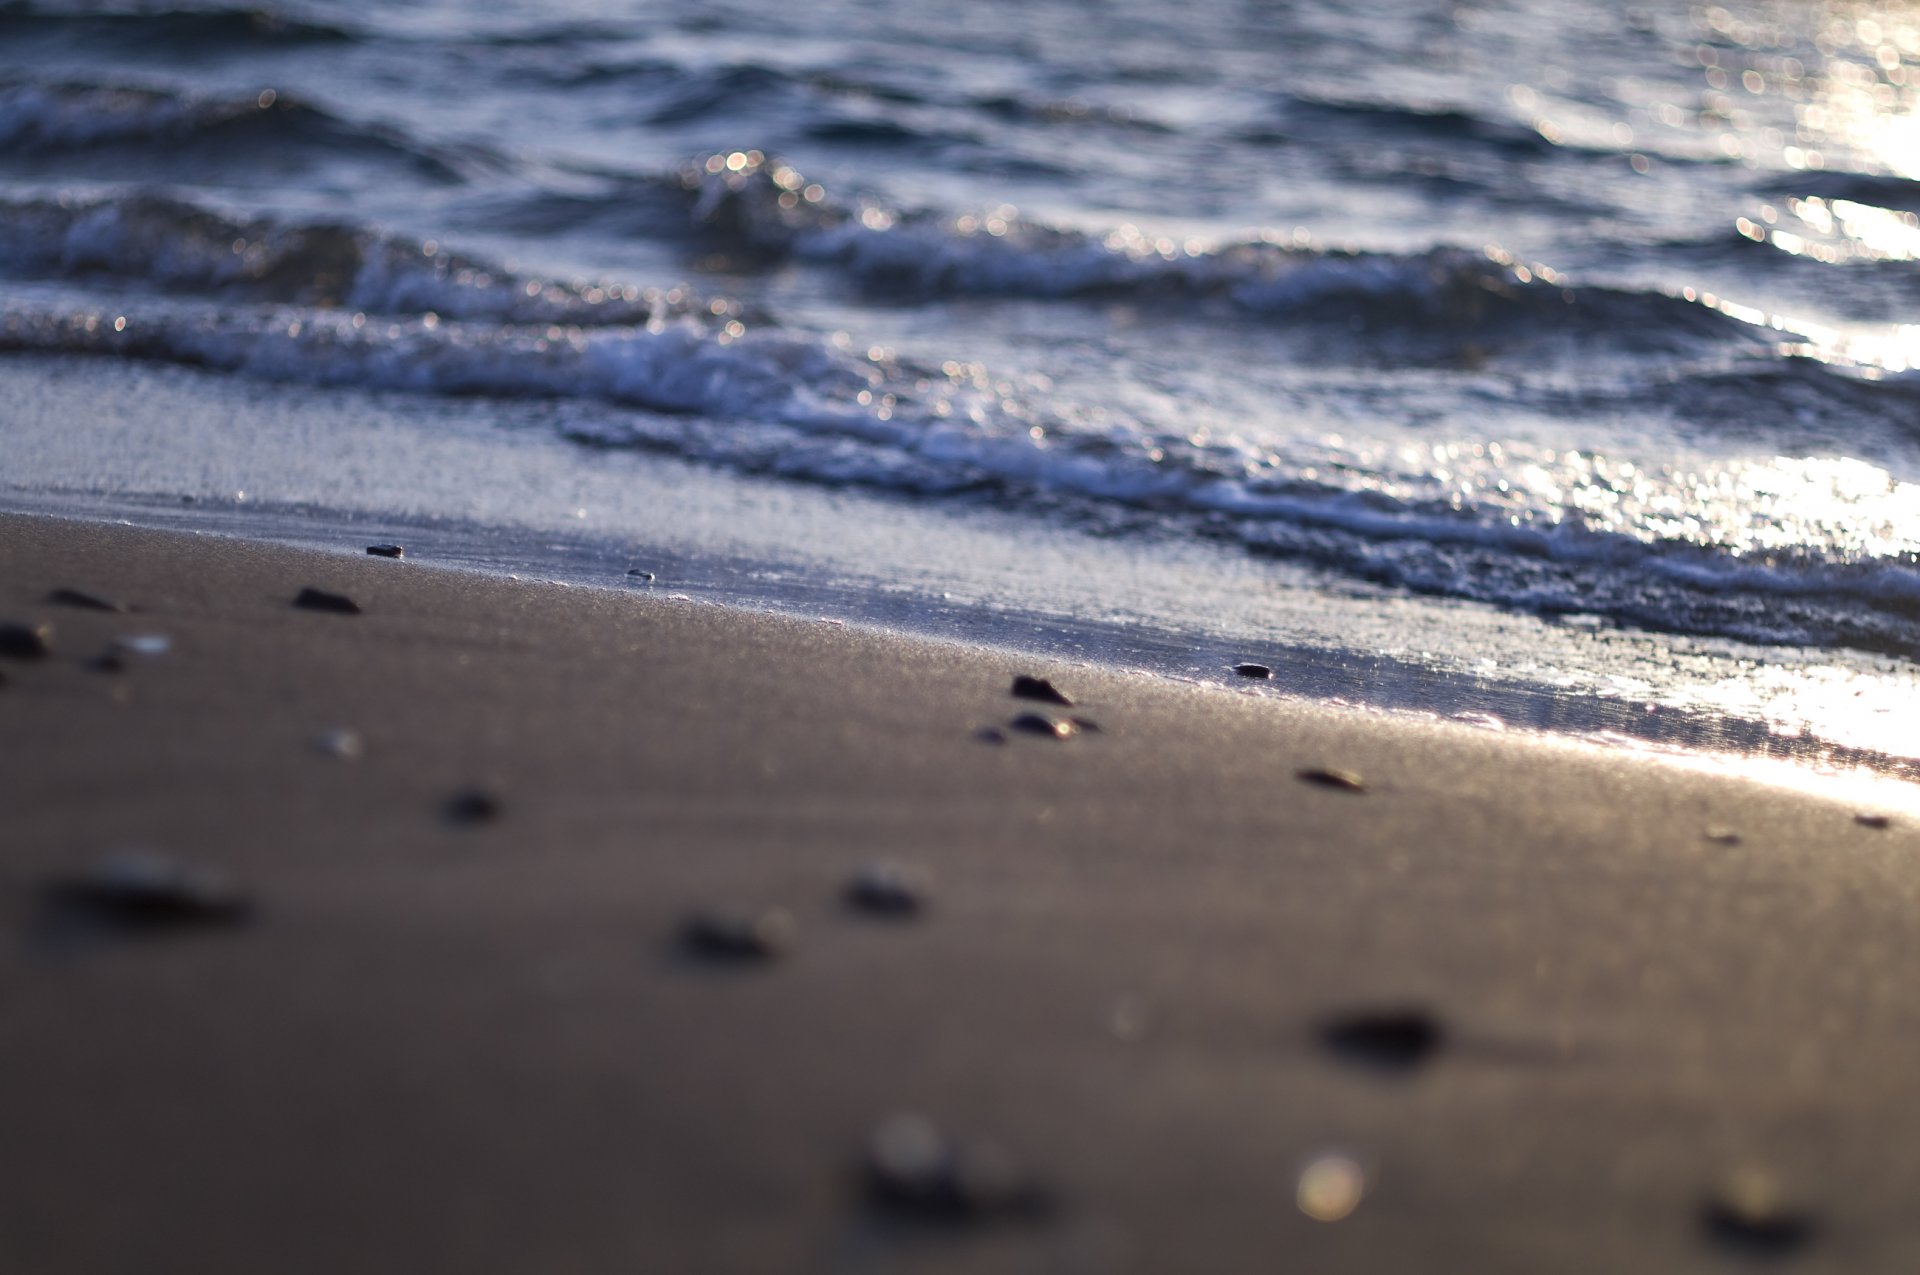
11 284 1920 655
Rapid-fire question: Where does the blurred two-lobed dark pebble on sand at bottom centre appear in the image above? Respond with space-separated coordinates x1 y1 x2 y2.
866 1116 1048 1225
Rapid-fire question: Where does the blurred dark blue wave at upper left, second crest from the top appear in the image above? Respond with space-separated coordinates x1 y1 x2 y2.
0 83 486 182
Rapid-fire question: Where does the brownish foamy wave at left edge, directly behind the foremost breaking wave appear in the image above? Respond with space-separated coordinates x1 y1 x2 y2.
0 194 741 326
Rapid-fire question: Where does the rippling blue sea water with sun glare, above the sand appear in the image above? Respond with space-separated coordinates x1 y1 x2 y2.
0 0 1920 772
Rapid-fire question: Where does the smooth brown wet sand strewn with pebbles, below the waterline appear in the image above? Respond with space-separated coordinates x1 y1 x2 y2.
0 517 1920 1273
